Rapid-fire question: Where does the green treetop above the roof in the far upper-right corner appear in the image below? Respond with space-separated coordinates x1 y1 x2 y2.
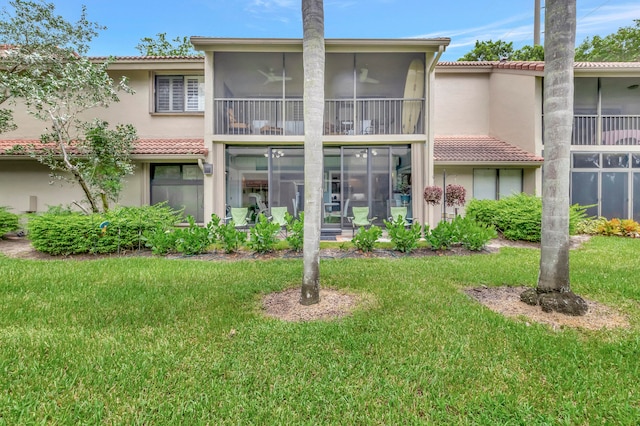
576 19 640 62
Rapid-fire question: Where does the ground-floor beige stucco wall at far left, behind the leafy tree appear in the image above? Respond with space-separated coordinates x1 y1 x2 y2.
0 160 148 214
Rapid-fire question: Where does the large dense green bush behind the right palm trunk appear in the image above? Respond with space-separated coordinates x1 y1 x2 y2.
466 193 589 242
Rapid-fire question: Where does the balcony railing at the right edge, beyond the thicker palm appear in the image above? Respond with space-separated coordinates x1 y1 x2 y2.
544 115 640 145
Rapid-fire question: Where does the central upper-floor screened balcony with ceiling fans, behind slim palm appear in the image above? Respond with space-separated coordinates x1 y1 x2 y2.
213 52 425 139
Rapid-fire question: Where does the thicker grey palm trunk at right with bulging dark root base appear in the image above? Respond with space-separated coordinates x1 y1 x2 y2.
520 0 588 315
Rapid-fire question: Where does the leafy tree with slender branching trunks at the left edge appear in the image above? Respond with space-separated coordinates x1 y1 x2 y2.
0 0 137 212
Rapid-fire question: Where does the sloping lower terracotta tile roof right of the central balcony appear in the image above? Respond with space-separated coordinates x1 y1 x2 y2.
433 135 544 163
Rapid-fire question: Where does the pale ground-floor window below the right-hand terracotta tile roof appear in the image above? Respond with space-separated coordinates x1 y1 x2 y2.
473 169 522 200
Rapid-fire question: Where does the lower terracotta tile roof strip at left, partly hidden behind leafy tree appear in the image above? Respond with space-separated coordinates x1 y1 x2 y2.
0 138 208 156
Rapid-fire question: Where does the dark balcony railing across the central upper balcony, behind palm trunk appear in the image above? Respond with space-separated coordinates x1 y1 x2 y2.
214 98 424 135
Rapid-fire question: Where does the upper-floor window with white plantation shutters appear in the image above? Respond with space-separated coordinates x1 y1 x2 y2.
155 75 204 112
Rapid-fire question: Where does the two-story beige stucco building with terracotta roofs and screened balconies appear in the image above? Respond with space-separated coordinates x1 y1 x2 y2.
0 37 640 233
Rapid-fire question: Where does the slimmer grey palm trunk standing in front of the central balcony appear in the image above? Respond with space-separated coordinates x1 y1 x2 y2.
300 0 325 305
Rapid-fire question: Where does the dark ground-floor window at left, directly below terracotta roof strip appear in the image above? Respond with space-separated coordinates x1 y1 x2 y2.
151 164 204 222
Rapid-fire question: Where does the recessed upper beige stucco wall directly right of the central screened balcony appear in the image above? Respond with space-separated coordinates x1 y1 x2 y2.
434 70 491 136
